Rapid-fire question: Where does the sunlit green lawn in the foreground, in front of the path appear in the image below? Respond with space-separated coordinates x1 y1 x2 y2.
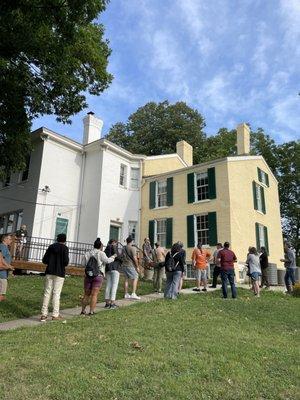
0 290 300 400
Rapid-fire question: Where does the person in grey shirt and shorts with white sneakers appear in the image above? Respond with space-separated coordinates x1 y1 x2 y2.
122 236 141 300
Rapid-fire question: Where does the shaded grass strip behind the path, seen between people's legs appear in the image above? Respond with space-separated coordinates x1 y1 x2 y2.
0 275 159 322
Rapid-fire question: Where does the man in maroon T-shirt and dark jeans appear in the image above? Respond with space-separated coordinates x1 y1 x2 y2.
218 242 237 299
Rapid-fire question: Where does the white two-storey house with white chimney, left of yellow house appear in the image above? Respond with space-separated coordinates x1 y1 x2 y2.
0 113 146 243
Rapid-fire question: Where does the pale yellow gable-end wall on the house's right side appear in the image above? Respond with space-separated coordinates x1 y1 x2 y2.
228 158 283 268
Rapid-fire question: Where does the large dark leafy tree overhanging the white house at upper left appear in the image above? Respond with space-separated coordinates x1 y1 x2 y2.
0 0 112 178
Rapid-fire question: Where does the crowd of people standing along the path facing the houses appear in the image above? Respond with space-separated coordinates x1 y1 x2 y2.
0 234 296 322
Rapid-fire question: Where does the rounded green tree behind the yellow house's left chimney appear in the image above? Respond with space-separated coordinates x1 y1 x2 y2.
106 101 205 163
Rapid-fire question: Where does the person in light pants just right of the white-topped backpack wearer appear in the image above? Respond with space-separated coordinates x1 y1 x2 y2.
104 239 121 310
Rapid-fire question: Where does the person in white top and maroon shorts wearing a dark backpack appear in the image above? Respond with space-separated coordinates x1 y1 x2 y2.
80 238 116 315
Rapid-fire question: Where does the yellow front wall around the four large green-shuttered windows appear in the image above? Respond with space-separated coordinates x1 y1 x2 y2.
140 160 231 261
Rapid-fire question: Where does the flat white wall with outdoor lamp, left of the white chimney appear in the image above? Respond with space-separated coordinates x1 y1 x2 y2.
32 138 83 241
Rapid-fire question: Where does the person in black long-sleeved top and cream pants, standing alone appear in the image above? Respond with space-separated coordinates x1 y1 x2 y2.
41 233 69 322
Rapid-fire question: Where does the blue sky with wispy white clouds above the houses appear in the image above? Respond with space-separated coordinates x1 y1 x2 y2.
33 0 300 143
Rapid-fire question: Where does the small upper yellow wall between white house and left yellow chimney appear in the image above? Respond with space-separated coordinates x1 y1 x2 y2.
142 153 186 177
